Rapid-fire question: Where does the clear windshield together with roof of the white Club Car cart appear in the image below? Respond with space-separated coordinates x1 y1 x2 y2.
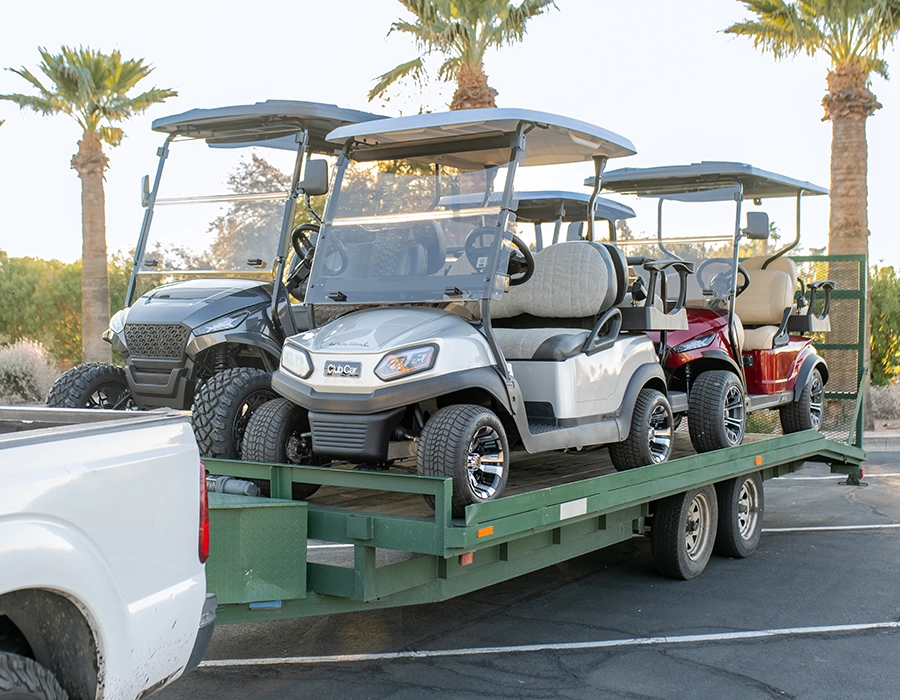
306 109 634 304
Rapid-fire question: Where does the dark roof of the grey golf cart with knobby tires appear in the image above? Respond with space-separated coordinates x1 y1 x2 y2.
153 100 383 152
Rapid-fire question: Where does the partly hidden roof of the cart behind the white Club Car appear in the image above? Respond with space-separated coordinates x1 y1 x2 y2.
439 190 635 222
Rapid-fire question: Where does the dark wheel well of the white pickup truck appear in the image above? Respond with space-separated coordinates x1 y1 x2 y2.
0 589 100 698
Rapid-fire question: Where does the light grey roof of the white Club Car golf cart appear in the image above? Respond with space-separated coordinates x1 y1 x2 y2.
328 109 636 168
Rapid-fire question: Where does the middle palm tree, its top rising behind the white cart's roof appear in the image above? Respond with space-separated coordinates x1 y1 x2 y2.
369 0 556 110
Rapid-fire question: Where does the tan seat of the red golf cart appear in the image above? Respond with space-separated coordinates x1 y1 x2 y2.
734 269 794 350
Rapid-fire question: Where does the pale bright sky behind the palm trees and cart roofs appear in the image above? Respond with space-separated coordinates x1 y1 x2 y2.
0 0 900 266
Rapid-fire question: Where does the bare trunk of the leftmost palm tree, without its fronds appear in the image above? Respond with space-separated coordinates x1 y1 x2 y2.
72 131 112 362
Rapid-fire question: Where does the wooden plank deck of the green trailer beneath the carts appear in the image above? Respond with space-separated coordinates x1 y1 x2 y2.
308 431 771 519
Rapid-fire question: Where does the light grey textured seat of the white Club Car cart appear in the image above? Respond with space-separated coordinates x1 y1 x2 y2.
491 241 621 361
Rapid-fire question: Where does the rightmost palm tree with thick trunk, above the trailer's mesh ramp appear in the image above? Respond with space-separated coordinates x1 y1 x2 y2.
725 0 900 255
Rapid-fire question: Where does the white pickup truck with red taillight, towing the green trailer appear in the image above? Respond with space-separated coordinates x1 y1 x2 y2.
0 407 216 700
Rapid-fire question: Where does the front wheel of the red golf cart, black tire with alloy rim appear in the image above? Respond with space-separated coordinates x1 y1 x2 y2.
688 369 747 452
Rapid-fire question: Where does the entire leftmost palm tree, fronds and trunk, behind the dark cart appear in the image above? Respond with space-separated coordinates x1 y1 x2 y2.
0 46 178 362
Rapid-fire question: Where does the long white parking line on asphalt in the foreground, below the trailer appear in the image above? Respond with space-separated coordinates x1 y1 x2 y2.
200 622 900 668
